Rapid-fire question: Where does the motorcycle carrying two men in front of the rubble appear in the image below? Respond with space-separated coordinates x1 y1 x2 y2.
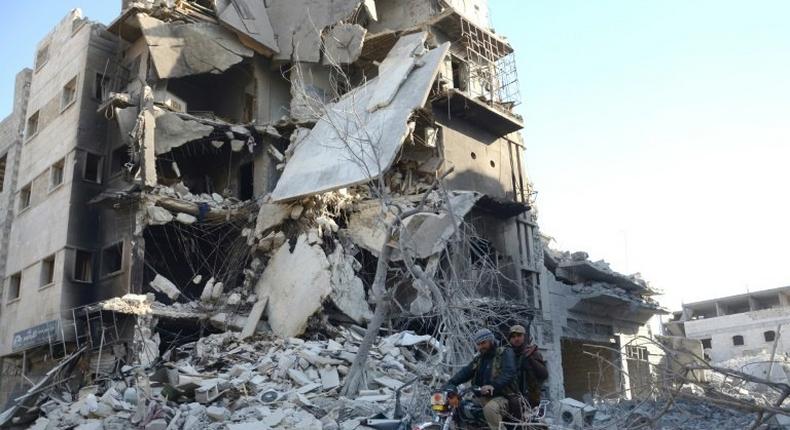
414 386 549 430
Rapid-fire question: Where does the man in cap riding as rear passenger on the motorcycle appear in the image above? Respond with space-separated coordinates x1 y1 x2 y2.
508 325 549 413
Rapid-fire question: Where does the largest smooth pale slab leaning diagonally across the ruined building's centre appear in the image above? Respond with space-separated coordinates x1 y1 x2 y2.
272 35 450 202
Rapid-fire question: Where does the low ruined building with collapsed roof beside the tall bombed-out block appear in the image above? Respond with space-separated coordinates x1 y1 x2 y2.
537 246 667 401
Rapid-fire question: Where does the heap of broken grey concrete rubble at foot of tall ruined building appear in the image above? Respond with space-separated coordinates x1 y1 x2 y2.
23 328 443 430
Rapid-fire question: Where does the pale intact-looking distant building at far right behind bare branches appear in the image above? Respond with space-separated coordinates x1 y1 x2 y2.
665 286 790 362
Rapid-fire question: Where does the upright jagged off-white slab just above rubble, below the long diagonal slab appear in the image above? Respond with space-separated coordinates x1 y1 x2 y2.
255 234 332 338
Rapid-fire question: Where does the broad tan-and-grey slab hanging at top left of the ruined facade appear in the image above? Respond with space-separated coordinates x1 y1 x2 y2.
135 14 253 79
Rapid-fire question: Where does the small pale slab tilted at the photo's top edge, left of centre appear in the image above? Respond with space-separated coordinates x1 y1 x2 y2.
214 0 280 57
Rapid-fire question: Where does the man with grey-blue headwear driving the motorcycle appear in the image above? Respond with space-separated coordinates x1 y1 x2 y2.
448 328 518 430
